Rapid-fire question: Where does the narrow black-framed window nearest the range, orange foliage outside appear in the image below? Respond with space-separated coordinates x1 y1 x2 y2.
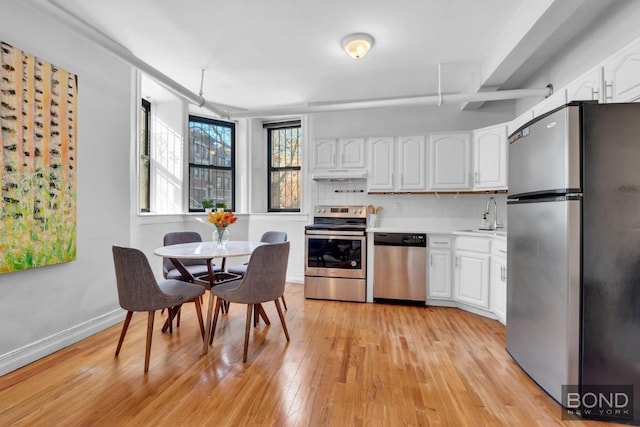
264 121 302 212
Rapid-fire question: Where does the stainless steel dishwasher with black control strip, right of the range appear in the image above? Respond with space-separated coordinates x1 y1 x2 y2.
373 233 427 304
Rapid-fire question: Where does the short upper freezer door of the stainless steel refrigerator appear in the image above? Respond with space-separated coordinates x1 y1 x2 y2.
509 105 580 198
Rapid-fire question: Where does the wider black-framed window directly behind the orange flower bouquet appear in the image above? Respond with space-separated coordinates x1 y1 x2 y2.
189 116 236 212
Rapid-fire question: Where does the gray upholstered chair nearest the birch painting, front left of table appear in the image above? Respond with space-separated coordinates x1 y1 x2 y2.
112 246 205 372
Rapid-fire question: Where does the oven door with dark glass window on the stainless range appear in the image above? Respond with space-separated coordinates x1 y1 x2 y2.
304 231 367 279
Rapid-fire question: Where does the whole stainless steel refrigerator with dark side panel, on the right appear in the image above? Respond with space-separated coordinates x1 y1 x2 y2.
506 102 640 422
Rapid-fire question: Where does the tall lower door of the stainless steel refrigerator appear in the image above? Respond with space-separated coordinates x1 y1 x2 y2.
507 198 581 402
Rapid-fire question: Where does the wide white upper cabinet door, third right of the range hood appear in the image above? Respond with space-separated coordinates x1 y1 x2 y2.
429 133 471 190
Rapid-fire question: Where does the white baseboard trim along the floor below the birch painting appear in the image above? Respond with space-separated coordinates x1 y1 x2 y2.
0 308 125 376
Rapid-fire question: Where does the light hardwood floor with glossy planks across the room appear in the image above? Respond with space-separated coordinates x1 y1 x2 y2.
0 284 624 427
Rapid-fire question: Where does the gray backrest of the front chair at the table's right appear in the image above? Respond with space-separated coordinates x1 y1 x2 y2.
234 242 290 304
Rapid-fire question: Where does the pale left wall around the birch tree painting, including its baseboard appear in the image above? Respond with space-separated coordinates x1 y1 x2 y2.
0 2 134 374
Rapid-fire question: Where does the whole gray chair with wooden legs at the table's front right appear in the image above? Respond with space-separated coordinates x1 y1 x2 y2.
211 242 290 362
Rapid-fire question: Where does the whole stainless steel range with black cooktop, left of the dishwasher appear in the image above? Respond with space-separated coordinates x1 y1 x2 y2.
304 206 367 302
